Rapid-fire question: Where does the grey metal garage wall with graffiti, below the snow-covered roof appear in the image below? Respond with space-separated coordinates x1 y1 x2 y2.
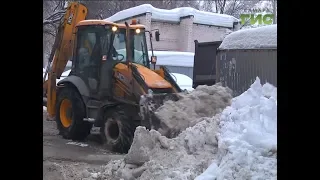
216 49 277 96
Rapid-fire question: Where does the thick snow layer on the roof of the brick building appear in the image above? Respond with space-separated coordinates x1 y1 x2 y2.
105 4 239 28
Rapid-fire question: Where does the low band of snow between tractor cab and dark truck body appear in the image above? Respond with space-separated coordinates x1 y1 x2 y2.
148 51 194 67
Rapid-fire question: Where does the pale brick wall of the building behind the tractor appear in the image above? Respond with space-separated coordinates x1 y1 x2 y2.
117 13 231 52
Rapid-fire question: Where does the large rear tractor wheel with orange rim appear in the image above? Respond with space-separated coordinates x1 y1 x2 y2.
56 87 92 141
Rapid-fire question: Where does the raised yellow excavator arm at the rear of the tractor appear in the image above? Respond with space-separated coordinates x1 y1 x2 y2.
43 2 88 119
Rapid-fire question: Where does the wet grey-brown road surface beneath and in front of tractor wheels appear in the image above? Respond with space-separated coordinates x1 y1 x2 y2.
43 112 124 180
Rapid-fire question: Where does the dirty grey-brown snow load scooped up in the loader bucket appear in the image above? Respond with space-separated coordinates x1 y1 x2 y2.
155 84 232 137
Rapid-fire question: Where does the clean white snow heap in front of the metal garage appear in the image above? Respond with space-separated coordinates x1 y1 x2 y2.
196 78 277 180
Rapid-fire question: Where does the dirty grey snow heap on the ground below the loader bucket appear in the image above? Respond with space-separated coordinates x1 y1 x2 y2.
92 118 222 180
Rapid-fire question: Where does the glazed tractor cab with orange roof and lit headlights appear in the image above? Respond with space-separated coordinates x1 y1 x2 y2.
59 20 154 100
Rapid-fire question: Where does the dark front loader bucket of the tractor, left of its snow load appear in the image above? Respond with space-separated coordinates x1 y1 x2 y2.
140 93 180 137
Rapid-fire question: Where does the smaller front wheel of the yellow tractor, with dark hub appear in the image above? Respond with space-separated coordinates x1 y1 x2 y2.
100 107 136 153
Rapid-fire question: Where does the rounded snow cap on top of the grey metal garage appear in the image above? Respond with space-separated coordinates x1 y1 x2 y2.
219 24 277 50
